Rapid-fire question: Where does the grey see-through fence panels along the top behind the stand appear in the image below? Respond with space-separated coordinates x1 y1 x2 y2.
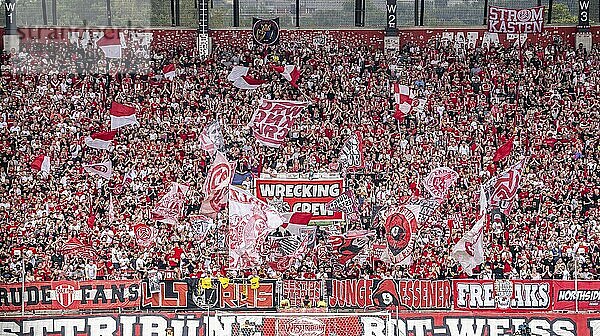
0 0 600 29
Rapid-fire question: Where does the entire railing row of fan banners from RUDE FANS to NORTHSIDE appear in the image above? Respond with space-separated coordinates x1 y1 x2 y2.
0 278 600 313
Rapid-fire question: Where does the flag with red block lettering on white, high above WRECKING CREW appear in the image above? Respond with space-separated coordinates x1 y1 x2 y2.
248 99 308 148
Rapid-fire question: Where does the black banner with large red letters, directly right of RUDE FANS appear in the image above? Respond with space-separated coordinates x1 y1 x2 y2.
141 279 277 310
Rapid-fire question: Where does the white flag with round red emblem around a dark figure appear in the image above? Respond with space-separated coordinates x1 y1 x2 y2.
380 205 421 265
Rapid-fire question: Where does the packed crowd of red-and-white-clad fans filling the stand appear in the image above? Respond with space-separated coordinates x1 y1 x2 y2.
0 30 600 283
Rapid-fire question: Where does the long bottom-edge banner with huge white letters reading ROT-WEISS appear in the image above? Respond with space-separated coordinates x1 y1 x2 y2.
0 312 600 336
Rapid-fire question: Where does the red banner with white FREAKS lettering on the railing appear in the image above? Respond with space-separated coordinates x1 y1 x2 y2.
452 280 552 312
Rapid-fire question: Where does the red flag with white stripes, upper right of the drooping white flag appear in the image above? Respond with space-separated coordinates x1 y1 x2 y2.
484 159 525 215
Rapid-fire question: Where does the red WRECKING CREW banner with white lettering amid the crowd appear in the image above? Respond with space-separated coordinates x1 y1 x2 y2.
256 179 344 221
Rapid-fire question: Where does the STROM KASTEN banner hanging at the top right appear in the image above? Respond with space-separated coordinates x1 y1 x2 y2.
488 6 544 34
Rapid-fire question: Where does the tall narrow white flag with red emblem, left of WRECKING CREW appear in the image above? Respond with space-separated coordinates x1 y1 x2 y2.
200 152 235 218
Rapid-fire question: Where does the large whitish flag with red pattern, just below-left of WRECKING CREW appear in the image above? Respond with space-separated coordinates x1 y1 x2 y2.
229 185 283 269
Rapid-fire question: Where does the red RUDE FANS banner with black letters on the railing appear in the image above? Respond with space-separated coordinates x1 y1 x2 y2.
0 281 140 312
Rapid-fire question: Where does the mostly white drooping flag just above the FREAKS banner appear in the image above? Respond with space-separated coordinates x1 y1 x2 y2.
450 215 486 275
